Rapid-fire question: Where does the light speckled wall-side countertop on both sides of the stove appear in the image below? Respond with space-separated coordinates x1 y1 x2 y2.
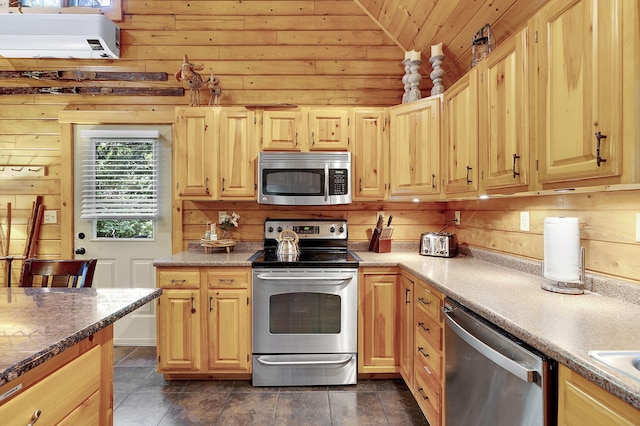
154 244 640 408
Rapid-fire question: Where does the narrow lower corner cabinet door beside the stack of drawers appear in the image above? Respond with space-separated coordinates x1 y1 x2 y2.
398 275 414 389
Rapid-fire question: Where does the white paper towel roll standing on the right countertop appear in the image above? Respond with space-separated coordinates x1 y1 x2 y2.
543 217 582 283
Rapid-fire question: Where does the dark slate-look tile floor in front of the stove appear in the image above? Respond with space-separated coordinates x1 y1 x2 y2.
113 346 428 426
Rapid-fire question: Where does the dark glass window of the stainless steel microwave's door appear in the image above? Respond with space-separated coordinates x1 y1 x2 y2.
262 169 324 196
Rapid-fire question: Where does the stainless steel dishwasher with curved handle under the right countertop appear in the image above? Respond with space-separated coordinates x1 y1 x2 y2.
444 298 557 426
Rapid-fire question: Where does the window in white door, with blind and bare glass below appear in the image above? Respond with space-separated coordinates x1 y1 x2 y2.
81 130 159 238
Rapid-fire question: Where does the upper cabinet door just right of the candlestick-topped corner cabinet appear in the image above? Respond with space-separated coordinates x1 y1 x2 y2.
443 67 479 195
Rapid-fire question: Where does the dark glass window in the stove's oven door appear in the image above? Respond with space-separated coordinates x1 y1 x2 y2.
269 292 342 334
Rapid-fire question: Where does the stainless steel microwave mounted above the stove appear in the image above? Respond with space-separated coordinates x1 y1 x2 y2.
258 152 351 206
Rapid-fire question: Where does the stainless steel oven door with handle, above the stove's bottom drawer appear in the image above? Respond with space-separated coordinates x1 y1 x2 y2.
252 268 358 354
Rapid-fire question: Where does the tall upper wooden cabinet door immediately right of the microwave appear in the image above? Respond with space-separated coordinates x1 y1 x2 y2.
352 108 389 201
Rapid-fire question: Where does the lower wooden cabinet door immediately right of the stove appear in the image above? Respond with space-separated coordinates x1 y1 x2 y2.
358 273 398 373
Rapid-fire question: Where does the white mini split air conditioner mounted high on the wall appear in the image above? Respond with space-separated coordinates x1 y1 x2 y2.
0 13 120 59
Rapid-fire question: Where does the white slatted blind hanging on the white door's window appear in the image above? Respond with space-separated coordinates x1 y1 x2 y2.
81 136 159 219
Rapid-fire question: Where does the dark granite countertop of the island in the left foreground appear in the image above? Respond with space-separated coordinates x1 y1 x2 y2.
0 287 162 385
